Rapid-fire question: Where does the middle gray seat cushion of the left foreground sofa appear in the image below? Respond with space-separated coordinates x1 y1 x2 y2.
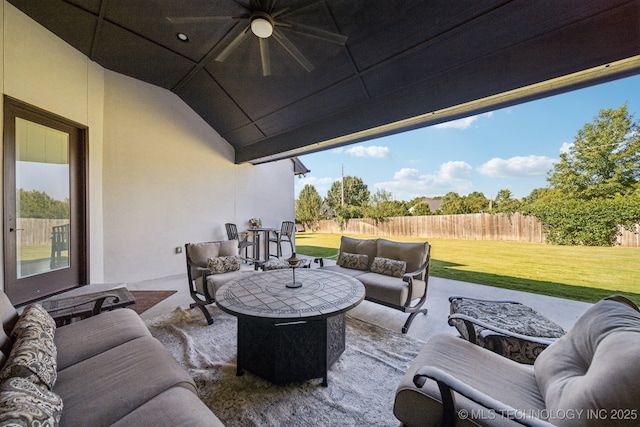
53 338 196 426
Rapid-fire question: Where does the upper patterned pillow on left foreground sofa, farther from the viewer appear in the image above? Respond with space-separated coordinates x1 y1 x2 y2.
0 321 58 390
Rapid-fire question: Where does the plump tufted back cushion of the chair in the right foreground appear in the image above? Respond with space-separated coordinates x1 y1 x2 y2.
534 300 640 426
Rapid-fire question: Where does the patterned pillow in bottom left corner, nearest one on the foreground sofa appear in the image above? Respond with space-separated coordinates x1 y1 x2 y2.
0 378 63 427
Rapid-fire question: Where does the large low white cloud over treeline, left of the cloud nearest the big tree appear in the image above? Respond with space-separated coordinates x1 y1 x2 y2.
374 161 473 200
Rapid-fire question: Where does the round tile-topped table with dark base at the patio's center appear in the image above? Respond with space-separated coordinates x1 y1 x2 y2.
216 269 365 387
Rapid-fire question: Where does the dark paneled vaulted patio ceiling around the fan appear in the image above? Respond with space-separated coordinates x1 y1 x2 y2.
9 0 640 163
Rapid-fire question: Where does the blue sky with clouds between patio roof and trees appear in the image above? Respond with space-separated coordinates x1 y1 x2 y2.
295 76 640 200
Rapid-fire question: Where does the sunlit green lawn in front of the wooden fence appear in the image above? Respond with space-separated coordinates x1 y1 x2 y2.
296 233 640 304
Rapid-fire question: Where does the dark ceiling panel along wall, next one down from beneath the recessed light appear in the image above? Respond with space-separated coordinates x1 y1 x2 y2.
175 70 250 135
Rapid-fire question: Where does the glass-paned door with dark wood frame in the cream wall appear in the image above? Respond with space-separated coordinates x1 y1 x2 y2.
4 97 88 304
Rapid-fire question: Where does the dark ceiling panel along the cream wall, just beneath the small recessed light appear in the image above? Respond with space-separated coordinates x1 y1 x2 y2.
93 22 195 89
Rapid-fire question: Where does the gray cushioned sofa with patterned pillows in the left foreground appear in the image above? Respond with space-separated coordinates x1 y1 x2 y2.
0 291 223 427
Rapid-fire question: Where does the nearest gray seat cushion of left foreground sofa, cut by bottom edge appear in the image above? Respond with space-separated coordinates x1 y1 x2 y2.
112 387 224 427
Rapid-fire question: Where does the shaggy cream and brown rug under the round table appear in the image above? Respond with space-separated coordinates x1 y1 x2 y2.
147 306 424 427
